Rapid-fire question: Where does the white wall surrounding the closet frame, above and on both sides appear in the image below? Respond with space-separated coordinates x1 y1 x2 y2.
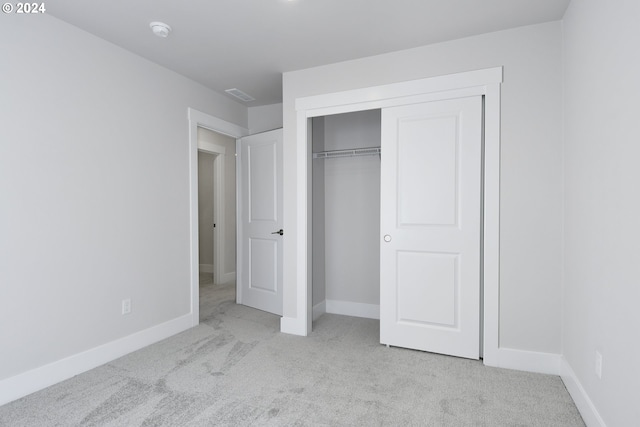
283 22 562 354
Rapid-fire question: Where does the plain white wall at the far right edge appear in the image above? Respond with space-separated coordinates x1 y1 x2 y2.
562 0 640 426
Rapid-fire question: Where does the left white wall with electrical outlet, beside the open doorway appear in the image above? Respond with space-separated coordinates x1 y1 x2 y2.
0 15 247 395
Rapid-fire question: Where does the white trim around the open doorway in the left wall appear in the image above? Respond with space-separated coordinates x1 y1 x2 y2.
187 108 249 326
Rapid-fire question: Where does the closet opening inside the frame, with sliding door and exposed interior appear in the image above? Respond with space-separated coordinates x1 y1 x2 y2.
311 96 482 359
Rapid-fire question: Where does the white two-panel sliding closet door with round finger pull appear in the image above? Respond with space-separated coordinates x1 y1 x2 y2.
380 97 482 359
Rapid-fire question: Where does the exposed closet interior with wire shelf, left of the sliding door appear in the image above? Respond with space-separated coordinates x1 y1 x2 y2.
311 109 381 320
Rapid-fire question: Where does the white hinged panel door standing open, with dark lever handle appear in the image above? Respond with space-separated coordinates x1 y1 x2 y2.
237 129 283 315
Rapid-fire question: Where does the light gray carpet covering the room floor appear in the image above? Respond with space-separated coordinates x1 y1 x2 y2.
0 285 584 427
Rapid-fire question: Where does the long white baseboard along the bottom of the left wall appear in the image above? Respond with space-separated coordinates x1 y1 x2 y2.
0 314 192 405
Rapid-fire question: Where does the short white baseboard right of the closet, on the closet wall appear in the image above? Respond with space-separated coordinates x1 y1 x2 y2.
484 347 562 375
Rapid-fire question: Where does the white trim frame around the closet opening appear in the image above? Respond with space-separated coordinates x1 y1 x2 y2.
290 67 503 366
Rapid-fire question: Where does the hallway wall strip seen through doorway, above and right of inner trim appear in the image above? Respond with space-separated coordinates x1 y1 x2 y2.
198 128 236 281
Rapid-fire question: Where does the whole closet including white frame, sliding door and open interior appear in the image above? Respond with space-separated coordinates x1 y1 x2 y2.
294 67 502 363
